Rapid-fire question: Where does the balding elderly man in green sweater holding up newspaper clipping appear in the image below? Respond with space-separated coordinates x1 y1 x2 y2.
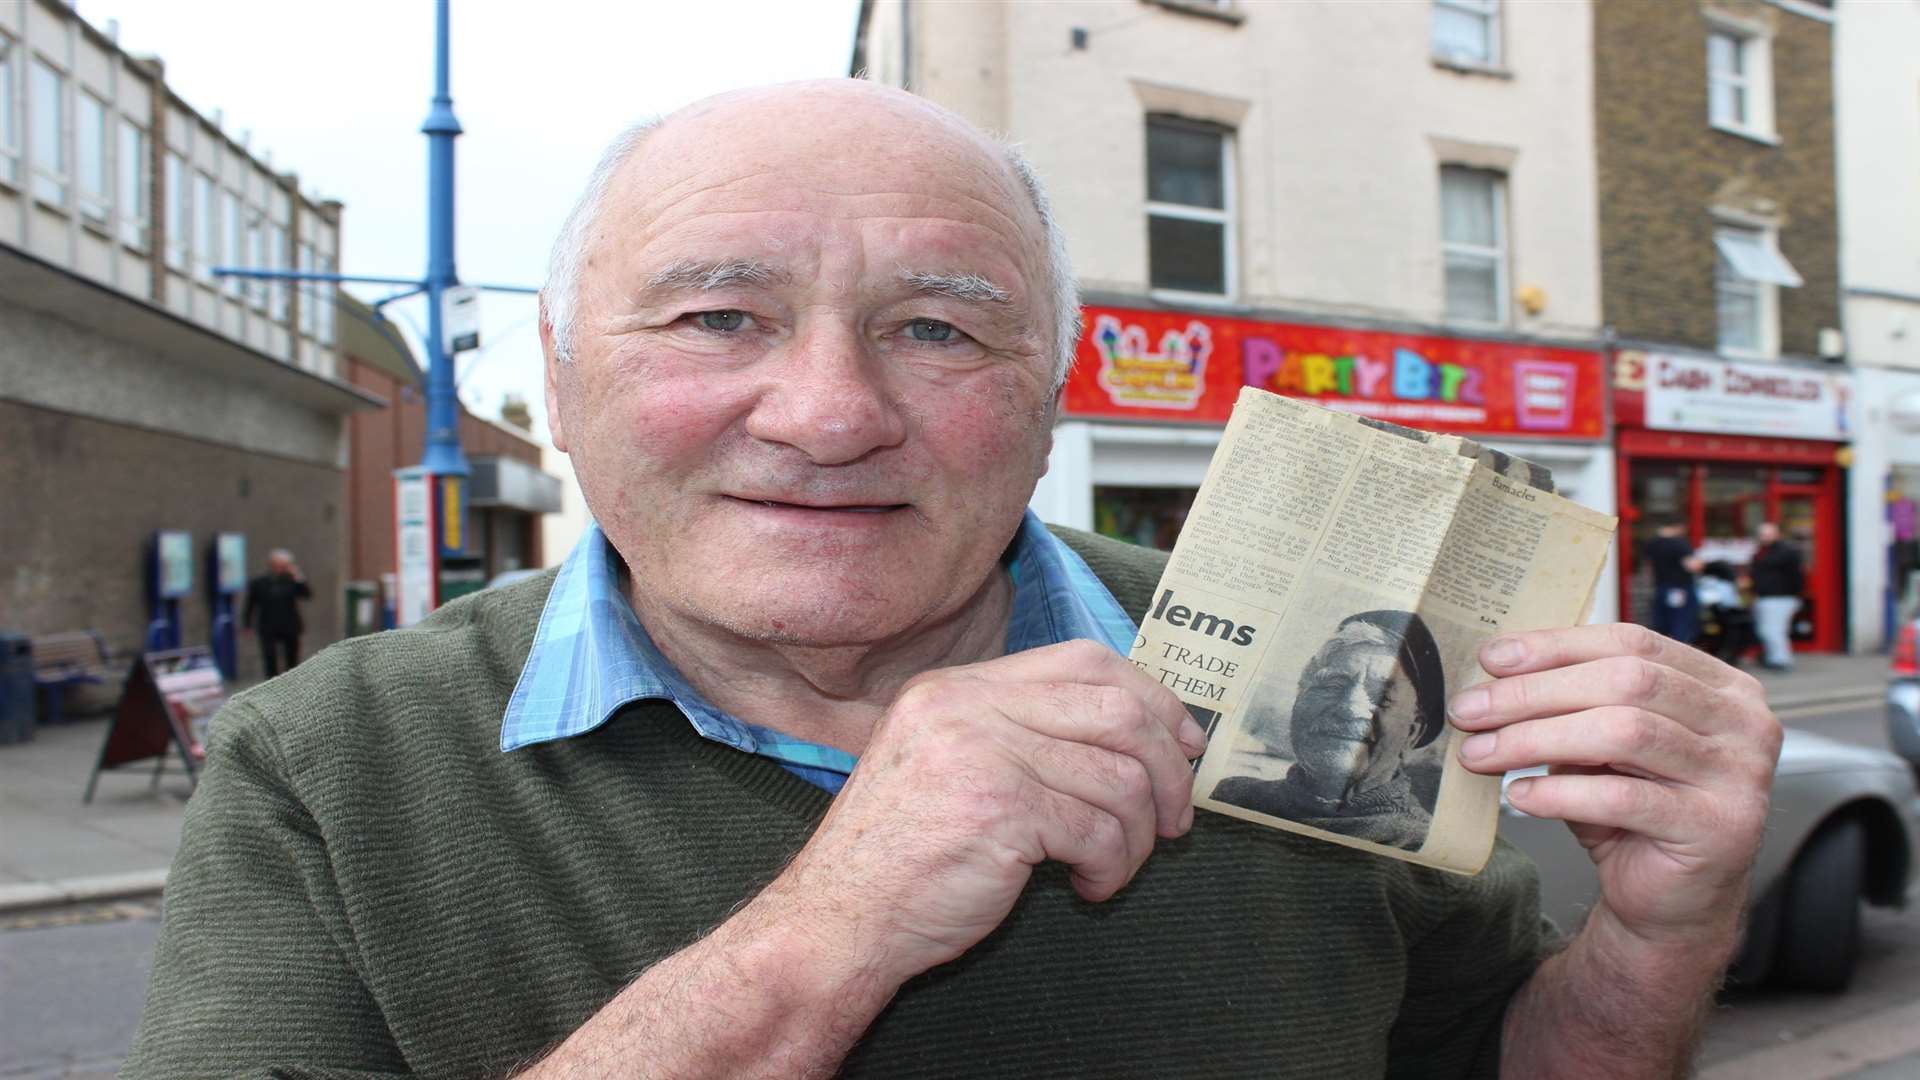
127 81 1778 1078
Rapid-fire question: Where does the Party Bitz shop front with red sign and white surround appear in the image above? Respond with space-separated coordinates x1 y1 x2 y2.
1033 306 1615 619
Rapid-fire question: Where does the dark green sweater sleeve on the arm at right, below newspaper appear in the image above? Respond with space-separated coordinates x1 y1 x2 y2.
1388 840 1557 1078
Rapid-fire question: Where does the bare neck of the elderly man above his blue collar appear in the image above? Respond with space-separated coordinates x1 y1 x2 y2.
624 567 1014 753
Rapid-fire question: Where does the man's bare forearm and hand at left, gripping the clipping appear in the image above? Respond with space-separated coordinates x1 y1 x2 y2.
526 642 1206 1078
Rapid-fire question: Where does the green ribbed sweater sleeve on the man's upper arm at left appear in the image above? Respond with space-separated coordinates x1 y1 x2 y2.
121 700 407 1080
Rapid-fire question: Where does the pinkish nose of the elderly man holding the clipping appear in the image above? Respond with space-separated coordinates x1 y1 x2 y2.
747 319 906 465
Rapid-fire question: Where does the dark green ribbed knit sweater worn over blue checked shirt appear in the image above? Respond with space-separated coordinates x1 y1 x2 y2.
125 530 1548 1080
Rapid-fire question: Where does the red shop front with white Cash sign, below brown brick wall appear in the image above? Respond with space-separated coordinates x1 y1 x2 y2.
1613 350 1853 651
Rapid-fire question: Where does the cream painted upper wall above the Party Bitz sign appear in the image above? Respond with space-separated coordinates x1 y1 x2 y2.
883 0 1599 338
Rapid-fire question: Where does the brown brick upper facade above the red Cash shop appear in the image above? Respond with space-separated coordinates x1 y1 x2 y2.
1594 0 1839 359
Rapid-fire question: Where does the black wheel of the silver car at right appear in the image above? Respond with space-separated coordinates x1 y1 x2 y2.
1772 819 1866 994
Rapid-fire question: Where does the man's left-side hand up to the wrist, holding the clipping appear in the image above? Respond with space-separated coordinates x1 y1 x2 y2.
755 642 1206 982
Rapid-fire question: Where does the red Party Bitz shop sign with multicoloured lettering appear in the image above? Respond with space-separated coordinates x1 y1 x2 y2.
1066 307 1605 438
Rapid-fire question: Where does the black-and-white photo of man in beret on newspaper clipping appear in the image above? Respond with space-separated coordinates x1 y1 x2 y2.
1213 609 1446 851
